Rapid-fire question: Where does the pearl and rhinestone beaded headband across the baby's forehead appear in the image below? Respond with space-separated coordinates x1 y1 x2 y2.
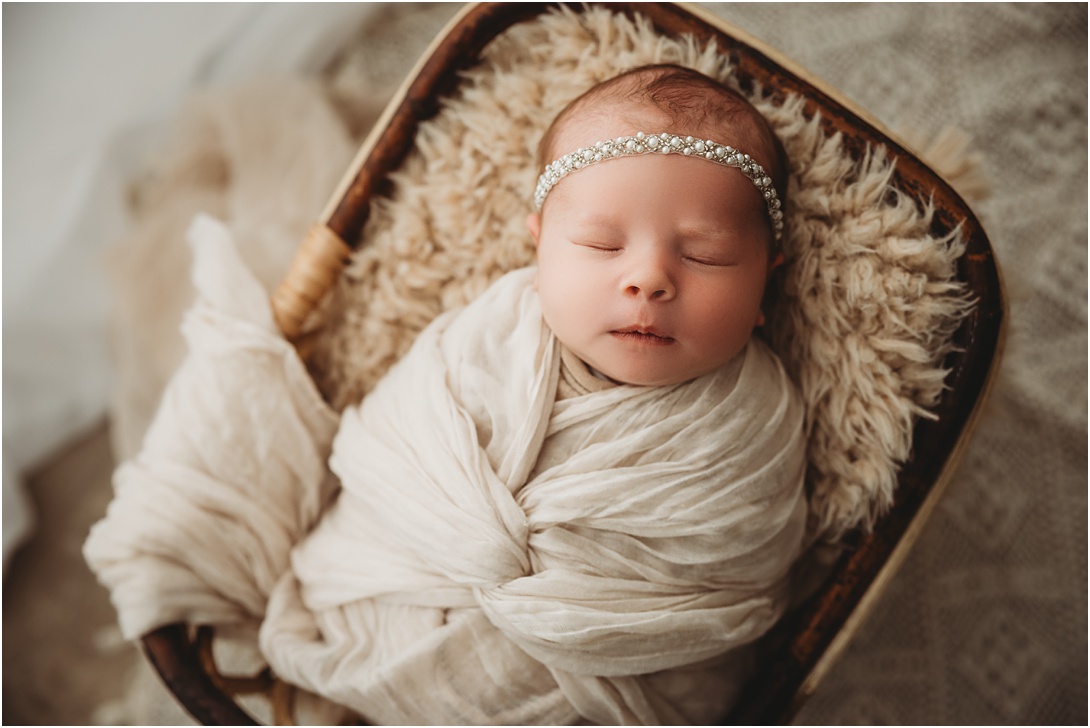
534 132 784 242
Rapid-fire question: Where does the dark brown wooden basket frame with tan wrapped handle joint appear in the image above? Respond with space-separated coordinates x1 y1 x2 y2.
144 3 1005 725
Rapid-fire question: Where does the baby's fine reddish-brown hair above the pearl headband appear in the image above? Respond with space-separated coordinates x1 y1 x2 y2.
537 63 787 210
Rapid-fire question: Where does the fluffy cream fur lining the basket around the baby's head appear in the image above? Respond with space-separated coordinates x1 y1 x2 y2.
303 5 967 535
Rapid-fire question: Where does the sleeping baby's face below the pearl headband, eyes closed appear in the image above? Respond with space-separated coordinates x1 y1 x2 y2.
528 142 773 385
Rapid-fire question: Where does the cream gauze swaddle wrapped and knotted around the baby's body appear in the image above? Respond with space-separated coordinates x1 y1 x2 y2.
262 258 806 723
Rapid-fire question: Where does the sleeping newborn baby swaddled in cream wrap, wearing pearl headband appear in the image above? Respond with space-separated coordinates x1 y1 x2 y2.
261 65 807 724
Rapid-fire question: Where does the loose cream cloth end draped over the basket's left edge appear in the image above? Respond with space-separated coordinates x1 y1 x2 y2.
84 216 338 639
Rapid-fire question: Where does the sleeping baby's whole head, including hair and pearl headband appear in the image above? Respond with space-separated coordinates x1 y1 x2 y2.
526 65 787 385
